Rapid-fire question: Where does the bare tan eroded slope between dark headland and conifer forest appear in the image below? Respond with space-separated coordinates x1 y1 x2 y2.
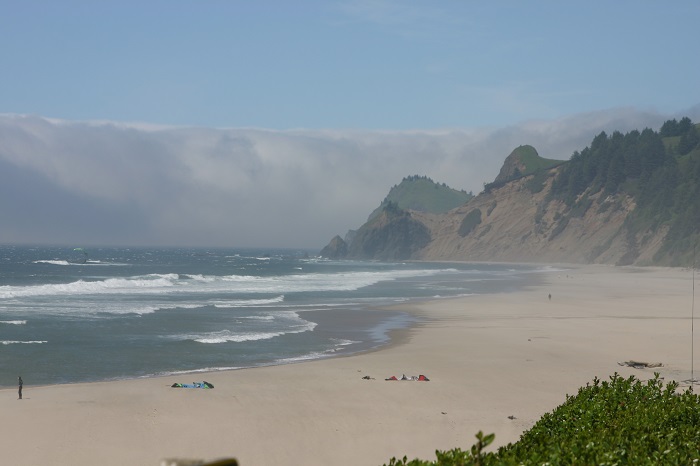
411 168 666 265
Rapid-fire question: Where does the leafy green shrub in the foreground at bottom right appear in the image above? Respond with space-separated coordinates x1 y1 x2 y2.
389 374 700 466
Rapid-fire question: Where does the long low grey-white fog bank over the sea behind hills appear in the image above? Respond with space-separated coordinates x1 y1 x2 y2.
0 107 684 249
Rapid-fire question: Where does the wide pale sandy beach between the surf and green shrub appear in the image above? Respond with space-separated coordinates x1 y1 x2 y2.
0 266 700 466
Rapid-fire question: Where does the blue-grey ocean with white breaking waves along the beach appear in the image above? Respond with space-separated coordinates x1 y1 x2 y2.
0 246 547 387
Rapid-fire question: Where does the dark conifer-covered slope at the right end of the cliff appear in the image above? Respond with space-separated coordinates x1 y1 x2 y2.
551 117 700 266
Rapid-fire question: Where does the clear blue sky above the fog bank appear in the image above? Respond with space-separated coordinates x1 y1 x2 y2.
5 0 700 130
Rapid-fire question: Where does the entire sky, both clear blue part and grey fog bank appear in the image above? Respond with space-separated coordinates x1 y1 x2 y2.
0 0 700 249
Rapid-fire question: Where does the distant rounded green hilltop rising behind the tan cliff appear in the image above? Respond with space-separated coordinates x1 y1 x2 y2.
369 175 474 219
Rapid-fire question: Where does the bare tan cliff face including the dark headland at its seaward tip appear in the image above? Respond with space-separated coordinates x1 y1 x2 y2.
321 167 667 265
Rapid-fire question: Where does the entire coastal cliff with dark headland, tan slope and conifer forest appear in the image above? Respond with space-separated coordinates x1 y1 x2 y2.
322 119 700 265
